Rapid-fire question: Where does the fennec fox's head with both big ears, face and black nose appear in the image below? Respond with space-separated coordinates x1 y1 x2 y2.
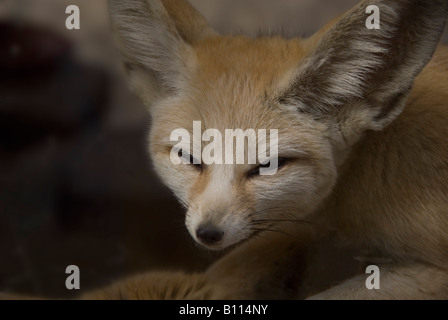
110 0 448 250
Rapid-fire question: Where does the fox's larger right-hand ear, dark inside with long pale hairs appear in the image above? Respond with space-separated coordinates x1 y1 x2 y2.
280 0 448 133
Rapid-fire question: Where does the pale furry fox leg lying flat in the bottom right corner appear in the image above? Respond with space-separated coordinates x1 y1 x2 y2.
308 264 448 300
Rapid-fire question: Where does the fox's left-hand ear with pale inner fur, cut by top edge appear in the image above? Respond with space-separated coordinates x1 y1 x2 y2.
109 0 214 102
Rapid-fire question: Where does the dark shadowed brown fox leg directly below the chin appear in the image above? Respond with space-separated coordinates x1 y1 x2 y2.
206 230 305 299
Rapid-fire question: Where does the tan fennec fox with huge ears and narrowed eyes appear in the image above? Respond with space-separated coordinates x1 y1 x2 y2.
110 0 448 299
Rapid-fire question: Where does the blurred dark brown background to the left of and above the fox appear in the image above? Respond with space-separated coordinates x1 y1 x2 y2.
0 0 446 297
